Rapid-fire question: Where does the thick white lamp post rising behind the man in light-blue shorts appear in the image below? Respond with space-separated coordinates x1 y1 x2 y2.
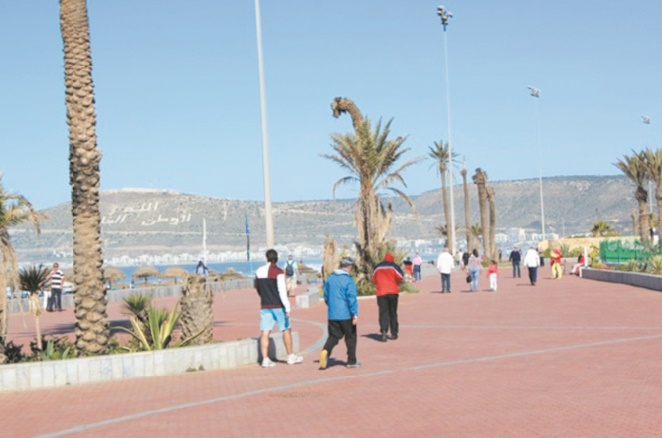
255 0 274 248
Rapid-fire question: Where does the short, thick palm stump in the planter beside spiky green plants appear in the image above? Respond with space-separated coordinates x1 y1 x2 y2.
179 275 214 345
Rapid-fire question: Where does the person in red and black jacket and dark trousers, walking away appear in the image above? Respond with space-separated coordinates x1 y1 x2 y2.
372 254 404 342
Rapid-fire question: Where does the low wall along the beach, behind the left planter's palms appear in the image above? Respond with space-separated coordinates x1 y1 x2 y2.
7 278 253 313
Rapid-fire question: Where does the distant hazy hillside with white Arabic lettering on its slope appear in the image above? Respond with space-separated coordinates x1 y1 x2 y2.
11 176 636 261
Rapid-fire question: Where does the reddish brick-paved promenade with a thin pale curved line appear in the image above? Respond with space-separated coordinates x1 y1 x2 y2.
0 267 662 438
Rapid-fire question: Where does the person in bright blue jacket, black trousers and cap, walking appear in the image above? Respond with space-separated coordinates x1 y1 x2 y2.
320 257 361 370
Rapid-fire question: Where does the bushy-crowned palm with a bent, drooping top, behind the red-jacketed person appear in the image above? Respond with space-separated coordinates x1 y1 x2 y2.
322 99 420 276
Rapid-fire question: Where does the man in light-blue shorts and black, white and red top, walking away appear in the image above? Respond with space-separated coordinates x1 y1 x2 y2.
255 249 303 368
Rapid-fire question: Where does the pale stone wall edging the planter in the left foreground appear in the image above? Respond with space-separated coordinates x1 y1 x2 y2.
0 332 299 392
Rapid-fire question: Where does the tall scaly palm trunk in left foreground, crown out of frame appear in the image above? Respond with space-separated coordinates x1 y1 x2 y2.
60 0 110 355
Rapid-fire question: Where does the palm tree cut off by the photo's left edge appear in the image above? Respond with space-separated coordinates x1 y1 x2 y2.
0 174 46 363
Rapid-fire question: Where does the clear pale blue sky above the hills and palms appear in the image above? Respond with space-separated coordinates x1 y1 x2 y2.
0 0 662 208
